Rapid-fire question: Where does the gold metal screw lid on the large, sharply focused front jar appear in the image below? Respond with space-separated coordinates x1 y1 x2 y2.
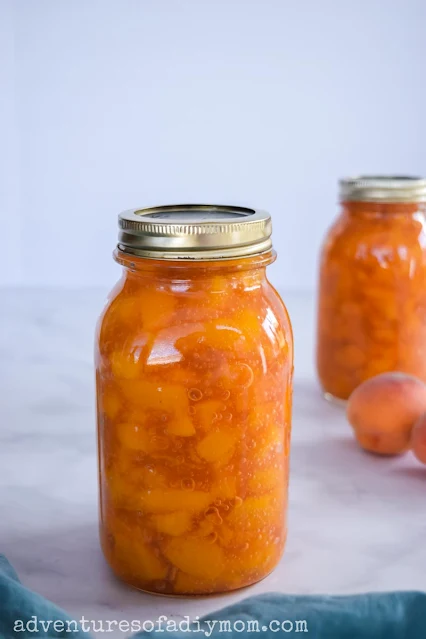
118 204 272 261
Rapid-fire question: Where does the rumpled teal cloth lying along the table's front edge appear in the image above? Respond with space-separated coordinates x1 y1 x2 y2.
0 555 426 639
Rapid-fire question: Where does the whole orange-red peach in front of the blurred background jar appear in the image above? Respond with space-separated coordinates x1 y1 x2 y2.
346 372 426 455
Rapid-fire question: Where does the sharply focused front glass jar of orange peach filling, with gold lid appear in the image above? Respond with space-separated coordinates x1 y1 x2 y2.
96 205 293 595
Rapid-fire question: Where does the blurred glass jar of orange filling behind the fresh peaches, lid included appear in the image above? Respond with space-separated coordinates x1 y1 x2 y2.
317 176 426 400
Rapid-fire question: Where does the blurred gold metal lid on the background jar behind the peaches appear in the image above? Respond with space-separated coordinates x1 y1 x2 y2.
339 175 426 203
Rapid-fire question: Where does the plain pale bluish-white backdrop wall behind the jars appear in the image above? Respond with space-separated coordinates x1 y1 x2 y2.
0 0 426 289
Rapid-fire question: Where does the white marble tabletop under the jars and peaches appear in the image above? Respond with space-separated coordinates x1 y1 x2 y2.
0 290 426 637
